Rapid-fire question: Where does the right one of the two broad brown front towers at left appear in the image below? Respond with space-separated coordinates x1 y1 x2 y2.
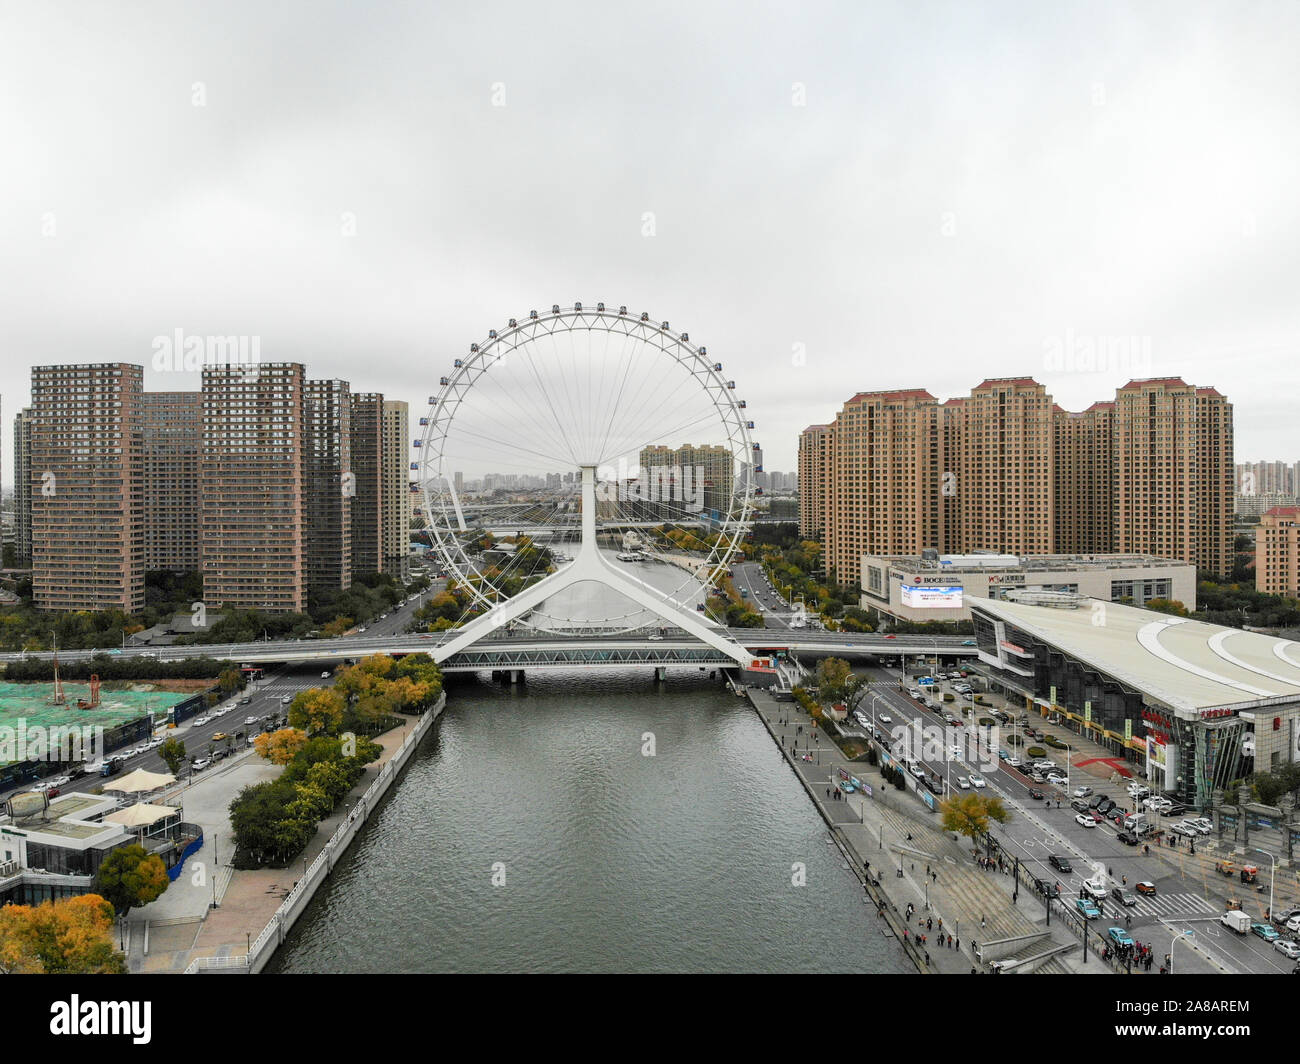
200 363 307 613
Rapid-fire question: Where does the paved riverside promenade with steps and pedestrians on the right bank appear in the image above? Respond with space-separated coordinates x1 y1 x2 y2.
746 689 1108 974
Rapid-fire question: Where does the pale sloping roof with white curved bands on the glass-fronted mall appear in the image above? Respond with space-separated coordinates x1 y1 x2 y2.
971 598 1300 714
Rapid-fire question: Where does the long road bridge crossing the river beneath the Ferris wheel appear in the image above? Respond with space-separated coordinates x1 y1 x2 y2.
0 628 975 672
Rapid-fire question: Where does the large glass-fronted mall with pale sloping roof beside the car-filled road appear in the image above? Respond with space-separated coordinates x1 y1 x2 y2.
970 591 1300 809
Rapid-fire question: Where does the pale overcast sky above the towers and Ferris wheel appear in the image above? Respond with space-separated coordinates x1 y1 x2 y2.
0 0 1300 484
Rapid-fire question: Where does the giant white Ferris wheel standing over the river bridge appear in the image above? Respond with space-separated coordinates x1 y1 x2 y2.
416 303 762 632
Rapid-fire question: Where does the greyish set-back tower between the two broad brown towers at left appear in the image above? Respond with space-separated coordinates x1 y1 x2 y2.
140 392 203 572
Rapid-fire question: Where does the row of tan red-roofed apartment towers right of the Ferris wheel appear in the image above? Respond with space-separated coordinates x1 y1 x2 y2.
800 377 1232 583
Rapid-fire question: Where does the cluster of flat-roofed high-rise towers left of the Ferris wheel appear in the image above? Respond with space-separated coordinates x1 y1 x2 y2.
13 363 412 613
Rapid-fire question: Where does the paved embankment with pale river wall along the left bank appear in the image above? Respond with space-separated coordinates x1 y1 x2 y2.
129 695 446 974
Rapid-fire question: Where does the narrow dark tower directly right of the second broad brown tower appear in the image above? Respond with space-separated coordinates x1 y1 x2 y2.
303 380 354 594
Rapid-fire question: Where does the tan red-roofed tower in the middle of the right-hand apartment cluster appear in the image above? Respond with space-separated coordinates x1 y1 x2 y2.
956 377 1056 554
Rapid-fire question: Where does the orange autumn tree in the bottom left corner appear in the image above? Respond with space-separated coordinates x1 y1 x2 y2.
0 894 126 976
